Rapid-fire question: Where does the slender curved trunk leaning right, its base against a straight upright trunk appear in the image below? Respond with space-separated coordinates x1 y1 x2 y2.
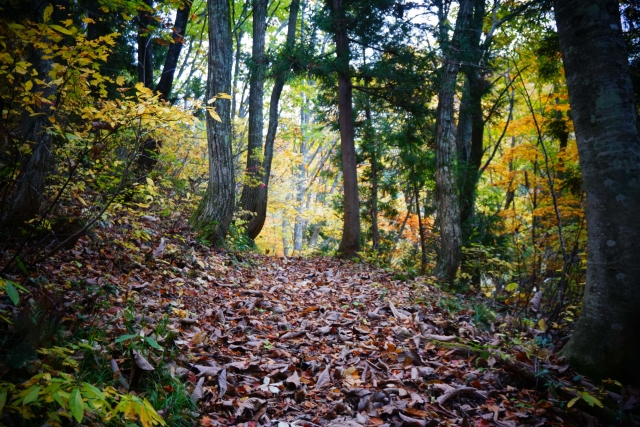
247 0 300 239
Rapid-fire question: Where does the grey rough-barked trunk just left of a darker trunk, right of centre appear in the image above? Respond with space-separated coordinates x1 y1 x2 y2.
435 0 473 283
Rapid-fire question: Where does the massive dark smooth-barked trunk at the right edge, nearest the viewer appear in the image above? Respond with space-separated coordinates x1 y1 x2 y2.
555 0 640 385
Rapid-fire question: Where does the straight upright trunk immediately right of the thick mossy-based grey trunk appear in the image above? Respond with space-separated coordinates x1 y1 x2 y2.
240 0 267 218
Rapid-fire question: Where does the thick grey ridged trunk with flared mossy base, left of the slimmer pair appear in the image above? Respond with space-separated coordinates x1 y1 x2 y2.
191 0 235 245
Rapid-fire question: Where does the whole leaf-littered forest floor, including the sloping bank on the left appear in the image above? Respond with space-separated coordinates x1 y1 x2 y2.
0 208 640 427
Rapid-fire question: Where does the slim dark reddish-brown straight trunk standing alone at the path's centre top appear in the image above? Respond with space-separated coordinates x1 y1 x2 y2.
330 0 360 259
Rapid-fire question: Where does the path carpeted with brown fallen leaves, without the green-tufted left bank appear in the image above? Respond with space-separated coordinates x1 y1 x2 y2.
121 256 592 427
